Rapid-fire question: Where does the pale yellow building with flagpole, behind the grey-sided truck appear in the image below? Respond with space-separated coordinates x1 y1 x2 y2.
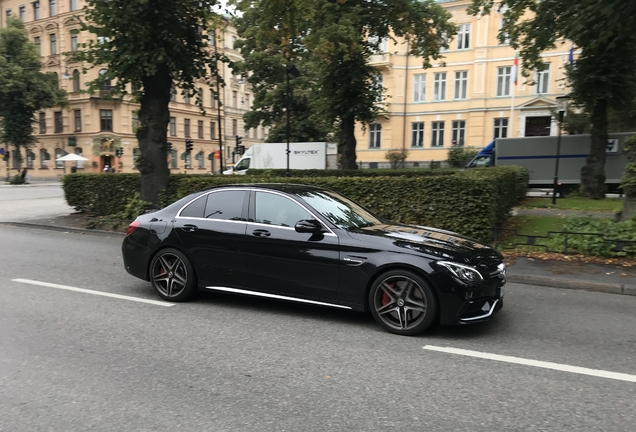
356 0 571 168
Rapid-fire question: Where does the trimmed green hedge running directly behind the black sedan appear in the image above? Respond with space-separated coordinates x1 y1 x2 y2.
64 167 528 241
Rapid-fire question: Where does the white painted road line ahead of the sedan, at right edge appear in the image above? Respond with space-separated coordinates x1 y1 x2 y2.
424 345 636 382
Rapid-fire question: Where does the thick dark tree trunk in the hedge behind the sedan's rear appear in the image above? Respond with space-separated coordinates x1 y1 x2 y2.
137 65 172 208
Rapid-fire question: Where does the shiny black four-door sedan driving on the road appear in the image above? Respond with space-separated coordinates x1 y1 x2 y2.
122 184 506 335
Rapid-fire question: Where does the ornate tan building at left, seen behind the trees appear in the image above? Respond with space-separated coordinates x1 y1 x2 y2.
0 0 266 180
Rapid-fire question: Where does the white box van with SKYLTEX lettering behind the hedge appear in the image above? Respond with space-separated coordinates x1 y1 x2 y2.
223 142 338 175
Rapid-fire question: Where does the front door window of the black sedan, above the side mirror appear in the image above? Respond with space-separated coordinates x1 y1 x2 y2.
255 192 314 227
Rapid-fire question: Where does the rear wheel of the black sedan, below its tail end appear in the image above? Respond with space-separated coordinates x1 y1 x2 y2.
150 248 197 302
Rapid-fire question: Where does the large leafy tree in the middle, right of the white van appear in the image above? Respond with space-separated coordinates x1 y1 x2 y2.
231 0 456 169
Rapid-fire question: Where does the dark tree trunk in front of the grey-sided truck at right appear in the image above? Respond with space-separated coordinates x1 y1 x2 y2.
579 100 608 199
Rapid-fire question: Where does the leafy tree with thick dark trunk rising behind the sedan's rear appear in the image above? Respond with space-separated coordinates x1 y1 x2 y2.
75 0 221 205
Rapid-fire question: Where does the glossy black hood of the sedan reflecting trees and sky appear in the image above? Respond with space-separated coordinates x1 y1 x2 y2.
349 224 501 261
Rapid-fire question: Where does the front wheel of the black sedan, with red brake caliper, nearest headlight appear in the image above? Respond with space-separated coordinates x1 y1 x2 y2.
369 270 437 336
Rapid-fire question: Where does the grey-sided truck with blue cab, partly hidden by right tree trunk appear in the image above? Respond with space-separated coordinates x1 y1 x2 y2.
466 132 635 194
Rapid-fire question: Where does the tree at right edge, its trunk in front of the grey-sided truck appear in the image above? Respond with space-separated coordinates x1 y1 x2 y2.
469 0 636 199
